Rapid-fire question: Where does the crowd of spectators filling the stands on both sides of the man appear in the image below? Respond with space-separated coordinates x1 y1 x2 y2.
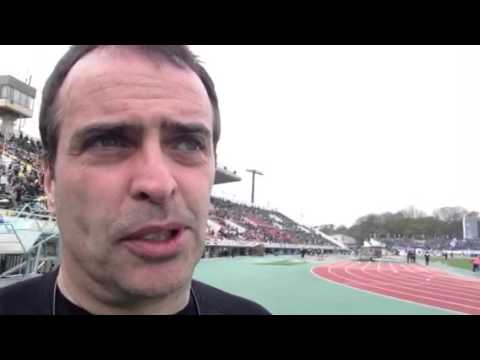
0 133 372 250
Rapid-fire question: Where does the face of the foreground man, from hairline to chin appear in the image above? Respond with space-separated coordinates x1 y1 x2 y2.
45 49 215 300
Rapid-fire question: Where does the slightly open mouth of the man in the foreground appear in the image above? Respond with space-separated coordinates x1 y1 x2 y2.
121 225 186 259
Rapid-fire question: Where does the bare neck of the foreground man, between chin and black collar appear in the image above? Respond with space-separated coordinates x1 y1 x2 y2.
57 263 191 315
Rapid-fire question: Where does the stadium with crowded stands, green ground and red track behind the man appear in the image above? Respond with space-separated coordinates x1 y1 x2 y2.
0 69 480 315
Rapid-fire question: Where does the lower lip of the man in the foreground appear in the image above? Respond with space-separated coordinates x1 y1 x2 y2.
123 229 185 259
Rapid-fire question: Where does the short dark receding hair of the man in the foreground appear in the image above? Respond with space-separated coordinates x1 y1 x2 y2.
39 45 220 164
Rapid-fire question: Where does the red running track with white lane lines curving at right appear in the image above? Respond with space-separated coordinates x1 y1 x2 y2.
312 261 480 315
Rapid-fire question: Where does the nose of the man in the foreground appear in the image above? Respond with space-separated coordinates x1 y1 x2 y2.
130 142 178 204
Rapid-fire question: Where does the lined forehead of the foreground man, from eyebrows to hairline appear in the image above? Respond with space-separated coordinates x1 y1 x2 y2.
57 47 213 129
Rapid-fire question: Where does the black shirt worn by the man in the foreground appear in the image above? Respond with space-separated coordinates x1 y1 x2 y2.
0 269 270 315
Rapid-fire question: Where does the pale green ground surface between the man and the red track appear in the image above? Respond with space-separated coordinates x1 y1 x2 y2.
194 256 452 315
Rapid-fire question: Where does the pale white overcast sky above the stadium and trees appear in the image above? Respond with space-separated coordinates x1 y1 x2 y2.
0 45 480 226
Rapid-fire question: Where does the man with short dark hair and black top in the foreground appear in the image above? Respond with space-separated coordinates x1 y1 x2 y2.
0 46 269 314
